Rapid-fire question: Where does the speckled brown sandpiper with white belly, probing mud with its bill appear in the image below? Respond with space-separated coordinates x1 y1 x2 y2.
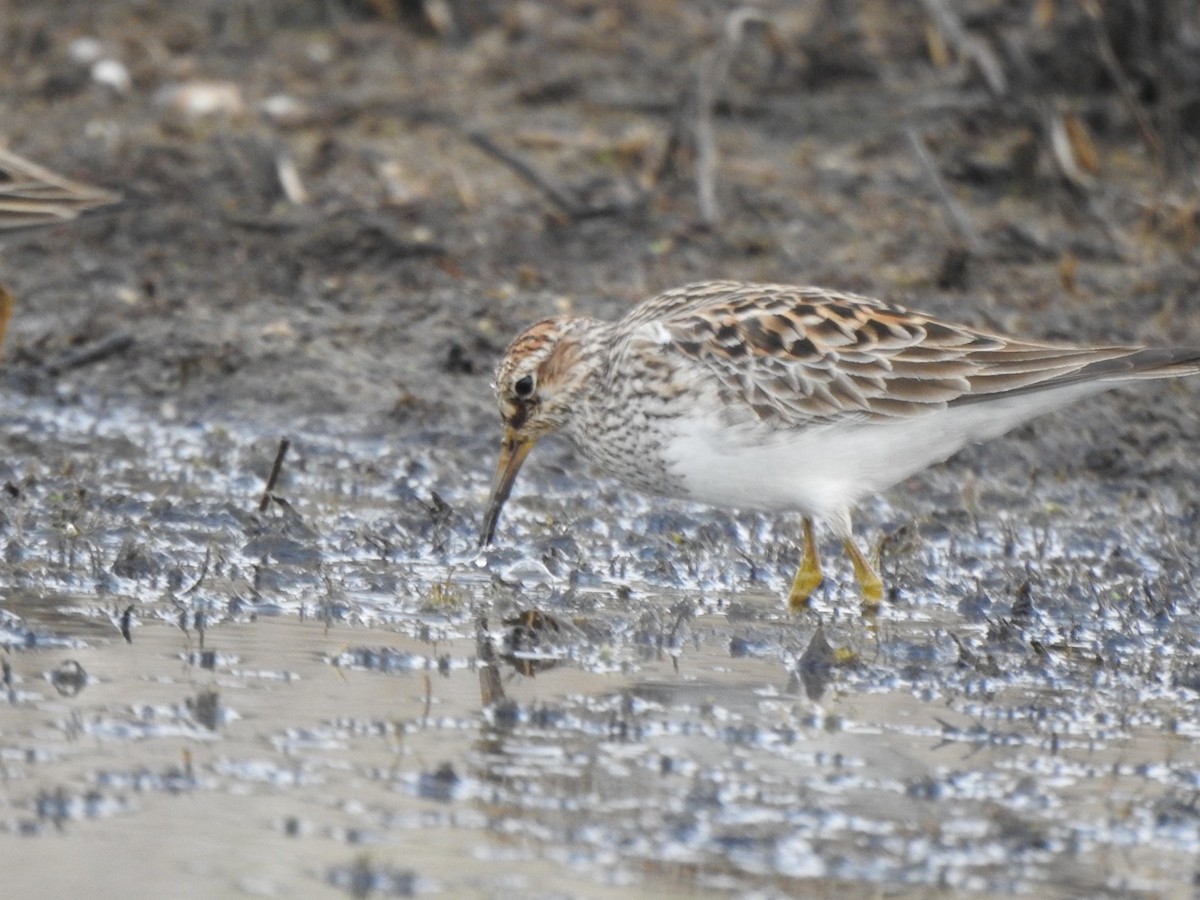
481 281 1200 610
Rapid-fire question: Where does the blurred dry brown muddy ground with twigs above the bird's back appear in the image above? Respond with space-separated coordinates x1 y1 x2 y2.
0 0 1200 434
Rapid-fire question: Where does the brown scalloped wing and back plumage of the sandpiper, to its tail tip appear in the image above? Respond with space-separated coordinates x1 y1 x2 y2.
619 282 1200 427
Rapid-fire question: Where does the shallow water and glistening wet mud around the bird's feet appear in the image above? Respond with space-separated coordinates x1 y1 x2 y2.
0 400 1200 896
